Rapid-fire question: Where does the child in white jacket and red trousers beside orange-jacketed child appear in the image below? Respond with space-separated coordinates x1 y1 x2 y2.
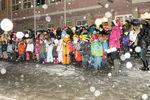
26 41 34 61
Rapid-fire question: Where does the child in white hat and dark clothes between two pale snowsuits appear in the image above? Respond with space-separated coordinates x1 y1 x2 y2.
52 39 59 64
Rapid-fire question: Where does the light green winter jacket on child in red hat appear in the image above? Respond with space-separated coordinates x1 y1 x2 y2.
91 41 103 57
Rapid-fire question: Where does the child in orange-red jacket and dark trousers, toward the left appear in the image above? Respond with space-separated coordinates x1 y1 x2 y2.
18 40 25 60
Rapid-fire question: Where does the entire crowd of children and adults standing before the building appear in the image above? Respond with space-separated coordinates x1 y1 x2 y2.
0 20 150 74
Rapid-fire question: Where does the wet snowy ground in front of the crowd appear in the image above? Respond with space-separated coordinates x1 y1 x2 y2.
0 58 150 100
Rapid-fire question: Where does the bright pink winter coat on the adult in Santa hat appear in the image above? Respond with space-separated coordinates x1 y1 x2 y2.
109 26 122 48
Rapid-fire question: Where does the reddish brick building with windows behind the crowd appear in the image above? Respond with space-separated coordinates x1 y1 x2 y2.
0 0 150 31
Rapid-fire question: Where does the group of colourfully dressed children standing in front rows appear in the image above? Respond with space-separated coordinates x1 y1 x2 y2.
0 25 108 70
